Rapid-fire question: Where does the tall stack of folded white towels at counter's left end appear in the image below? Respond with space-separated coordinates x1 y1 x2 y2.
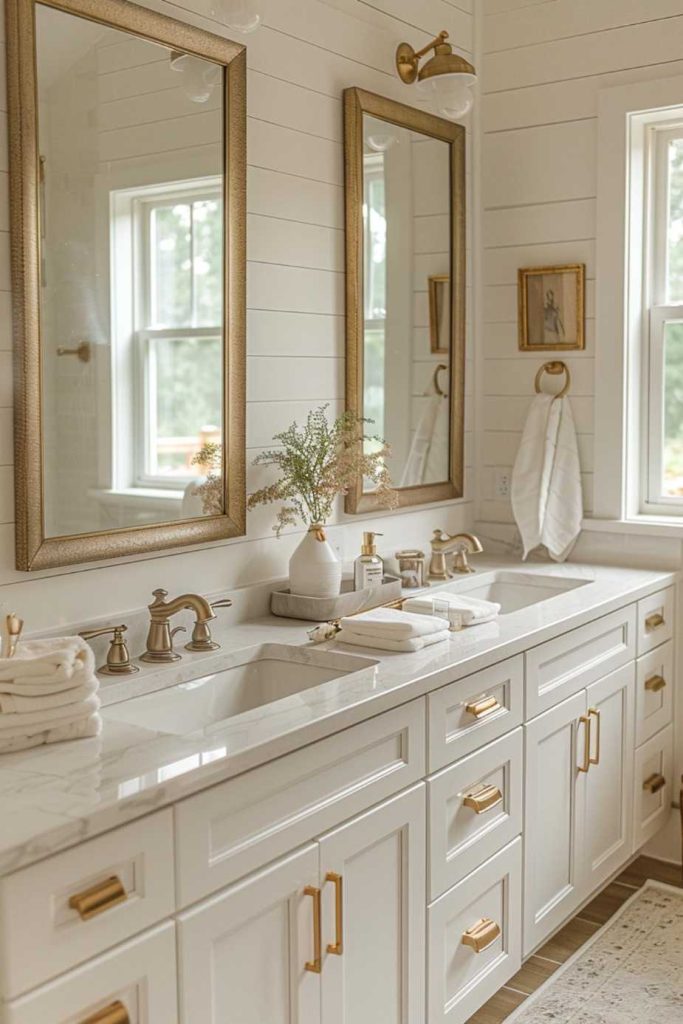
0 637 101 754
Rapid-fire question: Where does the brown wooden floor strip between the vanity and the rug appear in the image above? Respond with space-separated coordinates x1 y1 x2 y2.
468 857 683 1024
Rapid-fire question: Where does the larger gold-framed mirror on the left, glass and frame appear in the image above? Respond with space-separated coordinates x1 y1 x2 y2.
5 0 246 570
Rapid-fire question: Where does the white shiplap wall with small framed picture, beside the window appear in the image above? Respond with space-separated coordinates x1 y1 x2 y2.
477 0 683 536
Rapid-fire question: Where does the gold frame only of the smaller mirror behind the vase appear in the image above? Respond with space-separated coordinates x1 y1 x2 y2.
344 88 466 513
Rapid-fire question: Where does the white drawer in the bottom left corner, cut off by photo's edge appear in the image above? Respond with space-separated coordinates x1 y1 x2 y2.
2 922 178 1024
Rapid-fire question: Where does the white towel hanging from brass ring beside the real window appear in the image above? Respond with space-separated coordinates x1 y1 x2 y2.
512 394 584 562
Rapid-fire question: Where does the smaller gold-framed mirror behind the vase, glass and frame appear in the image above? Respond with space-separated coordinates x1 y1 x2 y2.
344 88 466 513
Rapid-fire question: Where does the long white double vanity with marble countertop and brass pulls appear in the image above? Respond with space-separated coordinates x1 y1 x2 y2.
0 564 676 1024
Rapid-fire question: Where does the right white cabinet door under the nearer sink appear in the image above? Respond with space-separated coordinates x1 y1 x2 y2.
319 783 426 1024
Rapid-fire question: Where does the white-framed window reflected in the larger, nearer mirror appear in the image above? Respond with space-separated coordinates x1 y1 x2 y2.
112 178 223 492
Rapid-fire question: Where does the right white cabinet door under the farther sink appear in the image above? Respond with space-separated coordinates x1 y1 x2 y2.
583 662 635 894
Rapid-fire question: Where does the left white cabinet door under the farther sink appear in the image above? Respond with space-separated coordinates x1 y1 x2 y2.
524 690 588 955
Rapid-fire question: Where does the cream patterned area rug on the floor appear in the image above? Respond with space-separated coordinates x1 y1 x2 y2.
505 882 683 1024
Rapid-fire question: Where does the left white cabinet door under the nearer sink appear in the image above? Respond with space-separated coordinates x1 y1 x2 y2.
178 844 321 1024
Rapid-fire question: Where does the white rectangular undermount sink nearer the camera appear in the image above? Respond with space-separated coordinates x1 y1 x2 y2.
102 643 377 736
